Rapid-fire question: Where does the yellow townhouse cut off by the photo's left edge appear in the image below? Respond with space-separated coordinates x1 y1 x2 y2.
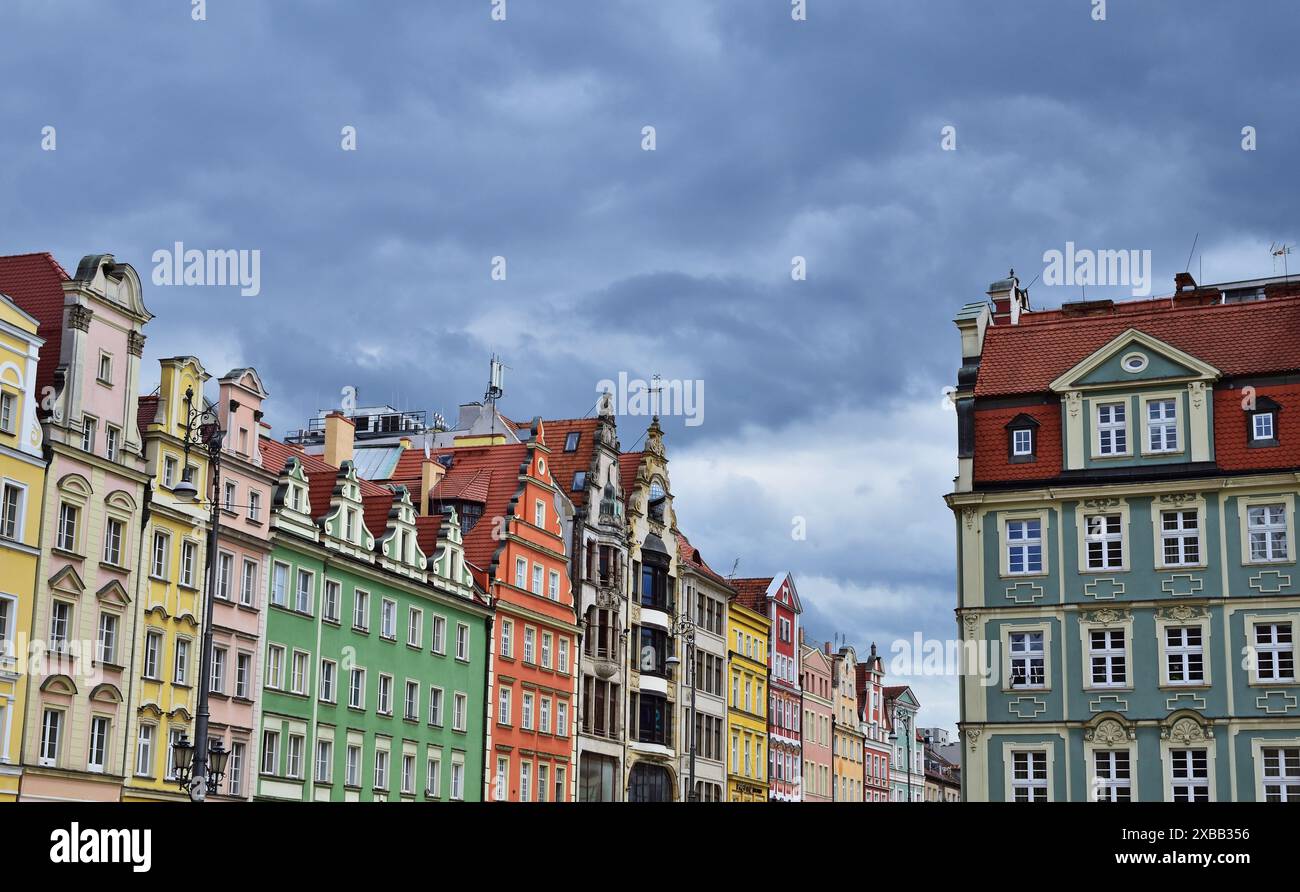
0 294 46 802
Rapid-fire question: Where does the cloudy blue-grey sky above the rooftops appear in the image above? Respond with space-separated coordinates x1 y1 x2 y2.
0 0 1300 727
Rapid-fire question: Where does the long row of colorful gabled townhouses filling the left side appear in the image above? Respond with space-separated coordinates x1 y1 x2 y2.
0 254 923 801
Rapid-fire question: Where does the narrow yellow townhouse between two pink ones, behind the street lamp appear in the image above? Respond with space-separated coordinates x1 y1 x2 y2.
122 356 213 801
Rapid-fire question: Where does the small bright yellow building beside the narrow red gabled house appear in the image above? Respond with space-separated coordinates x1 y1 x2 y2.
727 597 771 802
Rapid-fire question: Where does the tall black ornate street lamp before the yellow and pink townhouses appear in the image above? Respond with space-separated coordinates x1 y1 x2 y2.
173 387 229 802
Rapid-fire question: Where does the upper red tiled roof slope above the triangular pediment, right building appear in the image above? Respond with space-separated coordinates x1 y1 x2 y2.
975 296 1300 397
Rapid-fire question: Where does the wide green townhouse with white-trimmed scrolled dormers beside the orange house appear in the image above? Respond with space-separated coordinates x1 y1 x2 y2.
256 443 490 802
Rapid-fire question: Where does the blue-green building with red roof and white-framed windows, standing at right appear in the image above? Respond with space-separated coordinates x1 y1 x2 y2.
948 280 1300 802
